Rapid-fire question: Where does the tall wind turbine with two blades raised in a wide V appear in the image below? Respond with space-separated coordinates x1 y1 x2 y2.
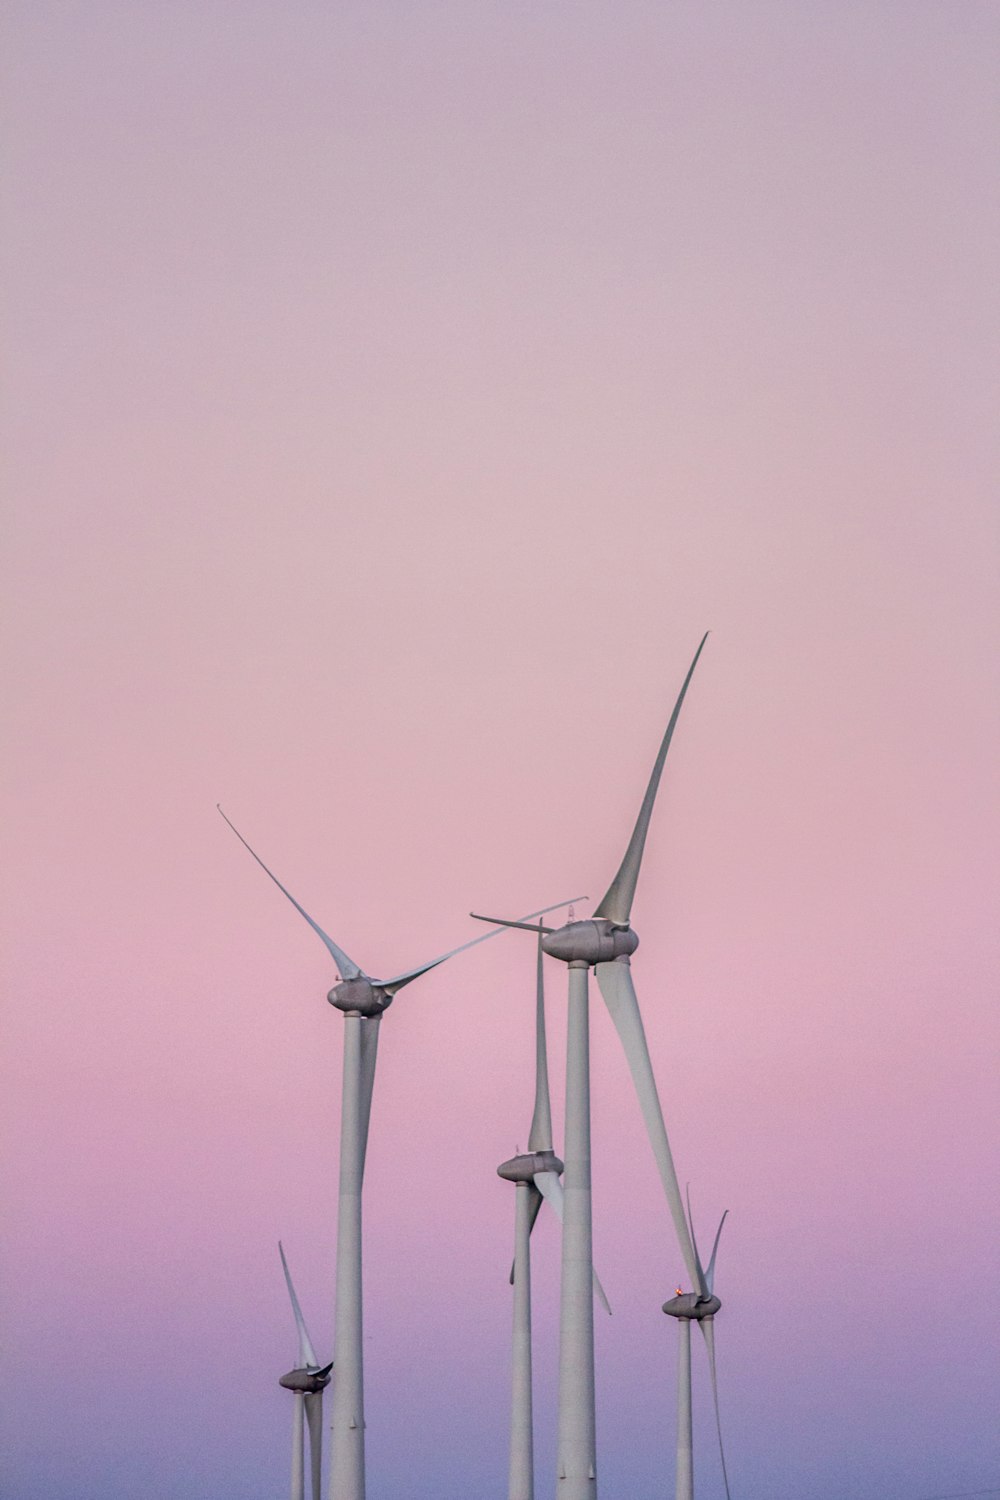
219 807 579 1500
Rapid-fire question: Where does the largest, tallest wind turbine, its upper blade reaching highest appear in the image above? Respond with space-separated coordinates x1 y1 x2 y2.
472 632 708 1500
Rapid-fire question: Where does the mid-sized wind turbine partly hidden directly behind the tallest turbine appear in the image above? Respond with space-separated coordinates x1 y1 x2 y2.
496 912 612 1500
